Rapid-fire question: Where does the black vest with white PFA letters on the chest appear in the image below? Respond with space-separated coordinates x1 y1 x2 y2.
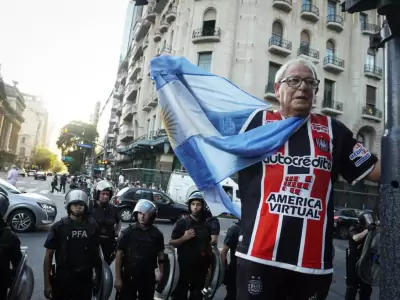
56 217 99 272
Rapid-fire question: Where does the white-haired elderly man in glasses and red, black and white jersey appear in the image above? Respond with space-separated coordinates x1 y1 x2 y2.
236 59 381 300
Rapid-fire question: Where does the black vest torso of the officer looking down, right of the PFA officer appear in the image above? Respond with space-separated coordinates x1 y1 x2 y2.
124 224 158 270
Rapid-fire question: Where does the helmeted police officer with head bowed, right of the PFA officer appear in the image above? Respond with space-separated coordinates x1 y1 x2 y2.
115 200 164 300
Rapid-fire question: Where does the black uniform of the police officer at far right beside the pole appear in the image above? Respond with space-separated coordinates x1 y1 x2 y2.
345 225 372 300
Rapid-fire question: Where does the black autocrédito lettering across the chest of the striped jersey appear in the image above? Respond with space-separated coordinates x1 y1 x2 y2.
264 153 332 171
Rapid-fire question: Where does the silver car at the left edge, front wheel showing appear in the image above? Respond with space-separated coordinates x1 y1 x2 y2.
0 179 57 232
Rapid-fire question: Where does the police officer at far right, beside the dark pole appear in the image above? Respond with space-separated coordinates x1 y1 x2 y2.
345 211 376 300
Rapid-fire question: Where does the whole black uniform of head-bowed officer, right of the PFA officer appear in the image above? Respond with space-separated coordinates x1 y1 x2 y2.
117 223 164 300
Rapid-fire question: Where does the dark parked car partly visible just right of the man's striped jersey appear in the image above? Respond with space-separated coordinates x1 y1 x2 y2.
333 208 361 239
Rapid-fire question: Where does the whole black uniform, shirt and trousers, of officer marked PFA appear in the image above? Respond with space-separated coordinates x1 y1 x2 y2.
44 217 101 300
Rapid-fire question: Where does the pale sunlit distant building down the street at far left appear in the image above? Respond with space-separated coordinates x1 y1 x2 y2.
17 94 49 167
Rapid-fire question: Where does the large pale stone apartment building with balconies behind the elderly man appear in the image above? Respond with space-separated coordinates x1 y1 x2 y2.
108 0 384 204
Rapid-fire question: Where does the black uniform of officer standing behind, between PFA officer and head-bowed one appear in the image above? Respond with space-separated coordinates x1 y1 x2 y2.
91 203 120 265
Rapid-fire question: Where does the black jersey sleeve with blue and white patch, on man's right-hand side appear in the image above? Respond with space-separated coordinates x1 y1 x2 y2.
335 121 378 185
